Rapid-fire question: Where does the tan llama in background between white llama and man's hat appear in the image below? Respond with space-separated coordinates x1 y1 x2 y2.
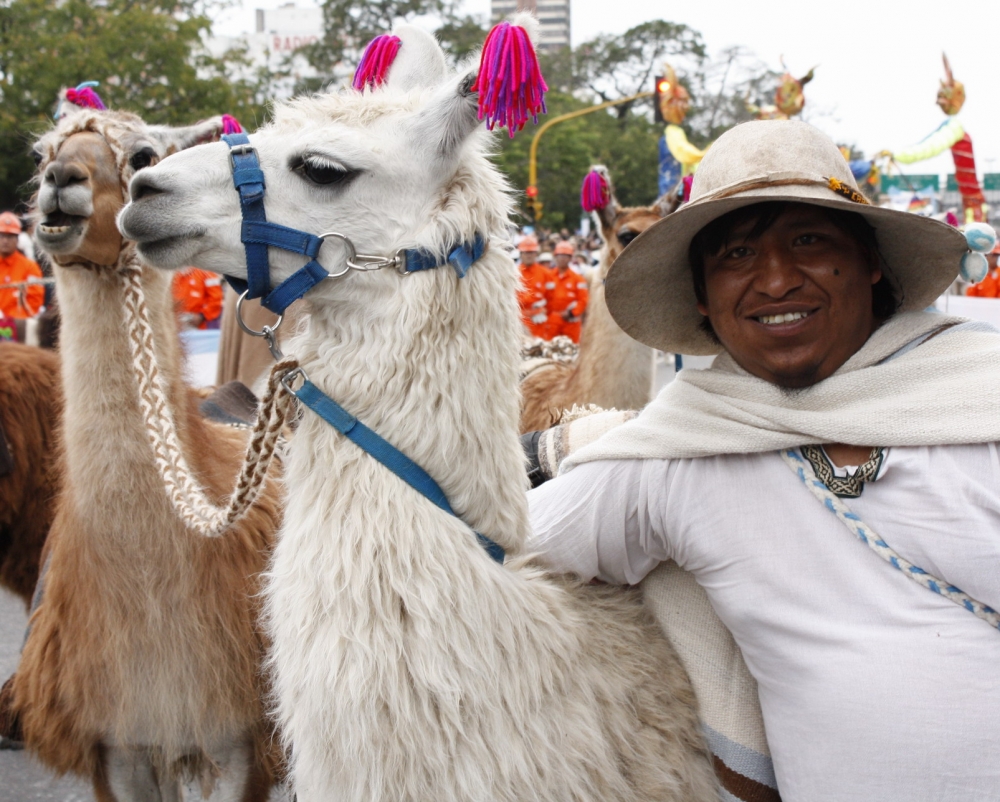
520 165 678 432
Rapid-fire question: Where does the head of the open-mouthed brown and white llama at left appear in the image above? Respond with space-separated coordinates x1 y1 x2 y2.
33 107 230 267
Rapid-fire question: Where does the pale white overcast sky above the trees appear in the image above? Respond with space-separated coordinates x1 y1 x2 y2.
220 0 1000 174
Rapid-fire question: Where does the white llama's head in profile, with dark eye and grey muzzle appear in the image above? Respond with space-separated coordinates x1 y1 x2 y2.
119 18 544 296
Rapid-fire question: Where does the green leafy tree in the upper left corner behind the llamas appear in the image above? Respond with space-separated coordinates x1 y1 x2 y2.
0 0 264 208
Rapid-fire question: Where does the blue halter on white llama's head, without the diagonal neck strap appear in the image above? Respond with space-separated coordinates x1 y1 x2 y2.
222 134 486 315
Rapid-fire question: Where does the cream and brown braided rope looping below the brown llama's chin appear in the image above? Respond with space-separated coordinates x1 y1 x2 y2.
120 260 298 537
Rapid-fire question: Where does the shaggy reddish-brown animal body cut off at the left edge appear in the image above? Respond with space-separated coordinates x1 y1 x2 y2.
0 343 63 608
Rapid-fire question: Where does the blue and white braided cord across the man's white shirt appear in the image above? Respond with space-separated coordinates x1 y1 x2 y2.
781 450 1000 629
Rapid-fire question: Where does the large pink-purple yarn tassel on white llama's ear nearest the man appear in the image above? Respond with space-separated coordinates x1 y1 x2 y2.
472 22 549 137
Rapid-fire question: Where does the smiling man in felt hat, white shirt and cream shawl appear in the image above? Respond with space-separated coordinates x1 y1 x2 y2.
529 121 1000 802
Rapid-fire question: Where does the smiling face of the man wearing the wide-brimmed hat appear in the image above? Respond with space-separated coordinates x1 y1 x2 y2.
698 204 882 388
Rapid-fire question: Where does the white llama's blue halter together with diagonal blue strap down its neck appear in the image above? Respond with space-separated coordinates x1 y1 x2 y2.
222 134 504 565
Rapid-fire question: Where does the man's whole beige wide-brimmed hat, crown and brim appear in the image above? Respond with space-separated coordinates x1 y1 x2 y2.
605 120 968 355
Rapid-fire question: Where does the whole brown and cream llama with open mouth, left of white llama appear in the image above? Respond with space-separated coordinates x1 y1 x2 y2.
13 110 280 802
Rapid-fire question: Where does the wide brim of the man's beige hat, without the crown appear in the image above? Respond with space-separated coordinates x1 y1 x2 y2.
605 185 968 356
